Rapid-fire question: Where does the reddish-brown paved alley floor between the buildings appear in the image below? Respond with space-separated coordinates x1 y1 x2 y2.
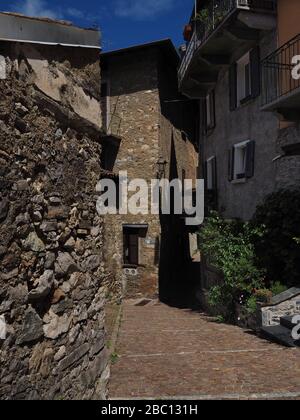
109 300 300 400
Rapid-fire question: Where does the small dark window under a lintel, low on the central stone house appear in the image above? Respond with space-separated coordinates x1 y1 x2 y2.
123 225 148 266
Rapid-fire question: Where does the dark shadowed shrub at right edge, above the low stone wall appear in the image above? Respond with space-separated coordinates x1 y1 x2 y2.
251 190 300 287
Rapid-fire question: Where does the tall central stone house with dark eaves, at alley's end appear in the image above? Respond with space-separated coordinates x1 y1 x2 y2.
101 40 198 306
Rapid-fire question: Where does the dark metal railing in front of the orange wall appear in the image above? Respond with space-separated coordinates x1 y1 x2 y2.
261 34 300 106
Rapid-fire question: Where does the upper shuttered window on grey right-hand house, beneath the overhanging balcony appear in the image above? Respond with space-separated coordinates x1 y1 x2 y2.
229 47 261 111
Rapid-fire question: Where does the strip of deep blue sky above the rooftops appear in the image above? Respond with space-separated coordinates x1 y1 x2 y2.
0 0 194 51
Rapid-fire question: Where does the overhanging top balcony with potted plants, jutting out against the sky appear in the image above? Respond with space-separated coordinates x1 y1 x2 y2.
178 0 277 98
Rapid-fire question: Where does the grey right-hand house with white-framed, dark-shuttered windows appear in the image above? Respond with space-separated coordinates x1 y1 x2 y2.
179 0 300 220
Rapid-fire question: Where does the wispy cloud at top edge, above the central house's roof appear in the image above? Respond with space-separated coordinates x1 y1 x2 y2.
115 0 176 20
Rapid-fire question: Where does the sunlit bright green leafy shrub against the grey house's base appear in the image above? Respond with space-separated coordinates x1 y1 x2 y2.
199 213 264 315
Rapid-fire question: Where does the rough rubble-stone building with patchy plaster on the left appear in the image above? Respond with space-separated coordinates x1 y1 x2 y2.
0 13 108 399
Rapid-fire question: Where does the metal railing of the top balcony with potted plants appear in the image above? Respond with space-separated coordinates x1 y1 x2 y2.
178 0 277 83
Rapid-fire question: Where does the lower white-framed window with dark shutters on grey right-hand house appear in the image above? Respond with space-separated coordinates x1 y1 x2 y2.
229 140 255 182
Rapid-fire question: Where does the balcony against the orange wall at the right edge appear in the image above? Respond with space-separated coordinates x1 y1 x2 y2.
262 34 300 121
